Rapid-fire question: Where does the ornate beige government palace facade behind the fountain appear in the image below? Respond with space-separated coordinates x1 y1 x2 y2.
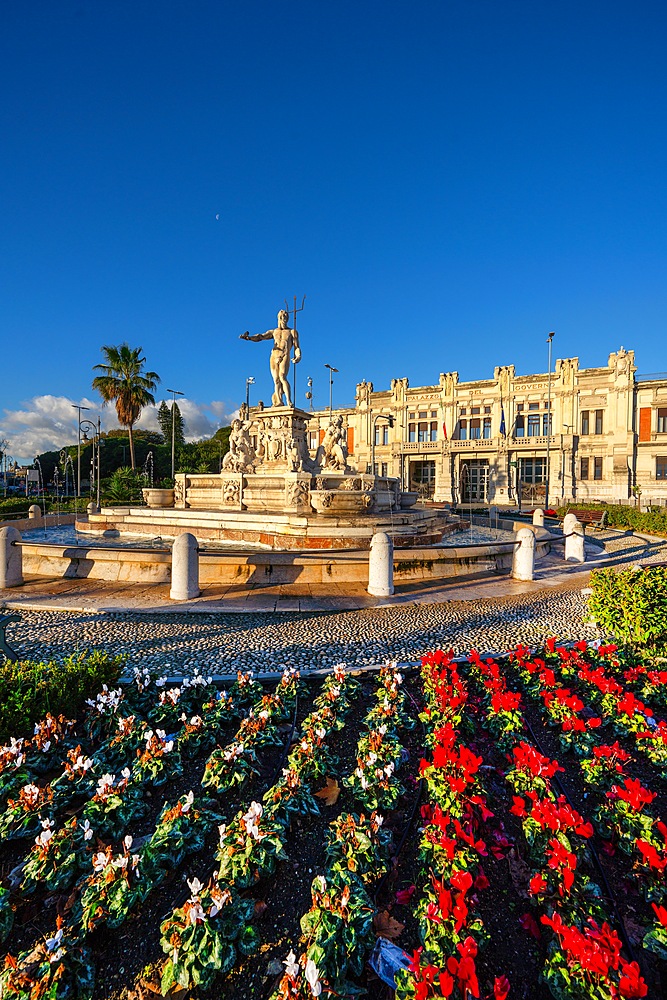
308 347 667 507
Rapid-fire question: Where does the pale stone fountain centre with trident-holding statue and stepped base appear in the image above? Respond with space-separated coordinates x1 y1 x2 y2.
77 310 458 550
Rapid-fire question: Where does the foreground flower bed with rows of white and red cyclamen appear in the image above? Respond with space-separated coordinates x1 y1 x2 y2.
0 640 667 1000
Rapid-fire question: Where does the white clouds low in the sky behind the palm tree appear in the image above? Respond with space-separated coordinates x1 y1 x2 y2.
0 396 237 464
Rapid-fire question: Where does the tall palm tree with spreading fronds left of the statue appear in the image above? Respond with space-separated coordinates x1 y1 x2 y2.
93 344 160 469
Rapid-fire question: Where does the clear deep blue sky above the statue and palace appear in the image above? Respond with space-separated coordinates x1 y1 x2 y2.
0 0 667 458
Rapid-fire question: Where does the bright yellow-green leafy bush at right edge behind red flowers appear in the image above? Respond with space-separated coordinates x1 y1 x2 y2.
588 566 667 653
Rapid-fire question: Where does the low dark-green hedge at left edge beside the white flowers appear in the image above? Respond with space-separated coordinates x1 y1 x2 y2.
0 651 126 743
